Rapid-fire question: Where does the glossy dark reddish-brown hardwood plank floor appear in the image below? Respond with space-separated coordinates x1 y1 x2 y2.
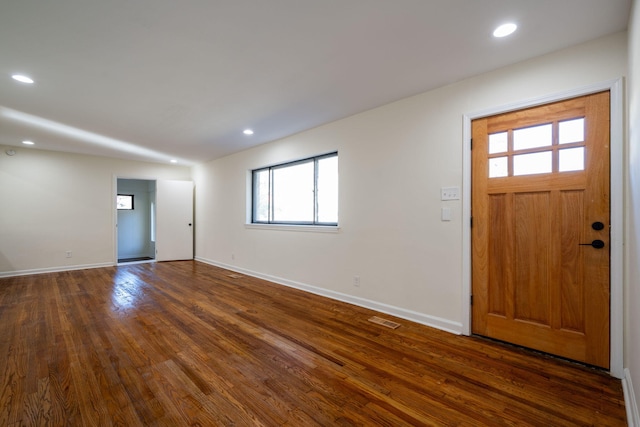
0 261 625 426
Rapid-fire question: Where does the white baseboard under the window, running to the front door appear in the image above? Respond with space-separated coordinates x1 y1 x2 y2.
195 257 462 335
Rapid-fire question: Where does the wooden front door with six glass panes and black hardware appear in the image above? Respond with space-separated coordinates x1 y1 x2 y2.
471 92 610 368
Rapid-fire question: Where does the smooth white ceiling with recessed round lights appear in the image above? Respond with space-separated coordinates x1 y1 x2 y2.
0 0 630 164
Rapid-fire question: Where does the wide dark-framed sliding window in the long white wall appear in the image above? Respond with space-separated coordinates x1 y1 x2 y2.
252 153 338 225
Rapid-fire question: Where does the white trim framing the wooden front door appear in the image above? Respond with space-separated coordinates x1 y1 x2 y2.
462 77 625 378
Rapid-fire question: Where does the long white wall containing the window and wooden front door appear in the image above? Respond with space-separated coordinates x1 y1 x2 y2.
194 33 627 331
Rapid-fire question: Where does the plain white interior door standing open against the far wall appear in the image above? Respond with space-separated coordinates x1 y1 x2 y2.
156 181 193 261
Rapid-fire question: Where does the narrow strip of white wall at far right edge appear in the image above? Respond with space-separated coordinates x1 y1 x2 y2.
625 0 640 425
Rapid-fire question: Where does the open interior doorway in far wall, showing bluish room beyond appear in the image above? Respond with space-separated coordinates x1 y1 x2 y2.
116 178 156 263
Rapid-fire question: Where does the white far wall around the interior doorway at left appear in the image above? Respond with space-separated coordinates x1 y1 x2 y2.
0 147 191 275
